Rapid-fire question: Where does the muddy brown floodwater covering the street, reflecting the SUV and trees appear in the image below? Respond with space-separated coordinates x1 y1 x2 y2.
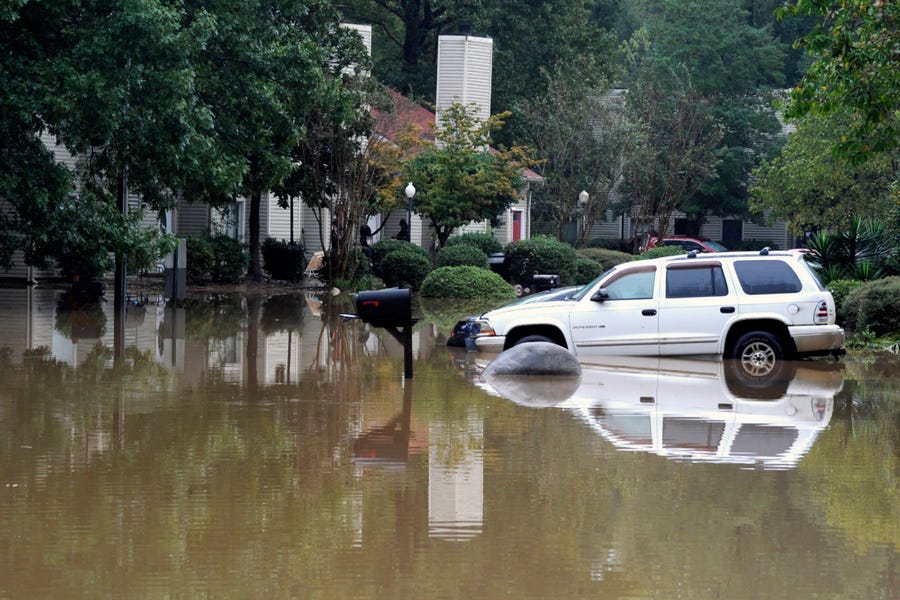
0 288 900 599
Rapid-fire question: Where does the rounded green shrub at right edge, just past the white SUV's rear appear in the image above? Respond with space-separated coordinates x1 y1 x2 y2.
843 276 900 336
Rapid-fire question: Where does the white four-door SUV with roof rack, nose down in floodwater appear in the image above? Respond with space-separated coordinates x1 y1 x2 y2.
472 249 844 374
